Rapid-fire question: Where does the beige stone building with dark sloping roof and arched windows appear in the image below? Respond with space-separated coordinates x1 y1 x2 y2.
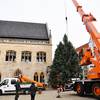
0 21 52 82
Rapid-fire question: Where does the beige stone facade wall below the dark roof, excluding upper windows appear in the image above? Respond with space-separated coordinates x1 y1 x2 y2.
0 38 52 81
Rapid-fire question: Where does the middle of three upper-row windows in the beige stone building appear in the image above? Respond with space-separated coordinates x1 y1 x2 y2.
21 51 31 62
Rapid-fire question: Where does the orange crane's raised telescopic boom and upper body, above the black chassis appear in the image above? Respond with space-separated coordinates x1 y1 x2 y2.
72 0 100 79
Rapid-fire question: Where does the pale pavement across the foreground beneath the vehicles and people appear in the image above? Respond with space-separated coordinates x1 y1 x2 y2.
0 90 96 100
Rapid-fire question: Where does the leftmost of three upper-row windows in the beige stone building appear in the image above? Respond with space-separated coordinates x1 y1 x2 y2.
5 50 16 61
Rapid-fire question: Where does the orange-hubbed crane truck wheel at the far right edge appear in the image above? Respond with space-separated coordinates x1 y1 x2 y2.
92 83 100 98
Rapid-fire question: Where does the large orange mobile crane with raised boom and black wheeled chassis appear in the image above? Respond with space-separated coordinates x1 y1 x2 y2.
72 0 100 98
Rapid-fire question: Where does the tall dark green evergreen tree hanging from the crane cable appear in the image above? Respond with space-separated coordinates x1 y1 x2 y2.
49 35 79 87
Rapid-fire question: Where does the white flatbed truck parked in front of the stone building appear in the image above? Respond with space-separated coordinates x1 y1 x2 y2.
0 78 31 95
